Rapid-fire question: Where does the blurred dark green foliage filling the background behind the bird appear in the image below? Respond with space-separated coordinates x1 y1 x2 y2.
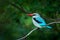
0 0 60 40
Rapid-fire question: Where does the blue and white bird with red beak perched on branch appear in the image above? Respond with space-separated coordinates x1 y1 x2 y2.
28 13 52 28
